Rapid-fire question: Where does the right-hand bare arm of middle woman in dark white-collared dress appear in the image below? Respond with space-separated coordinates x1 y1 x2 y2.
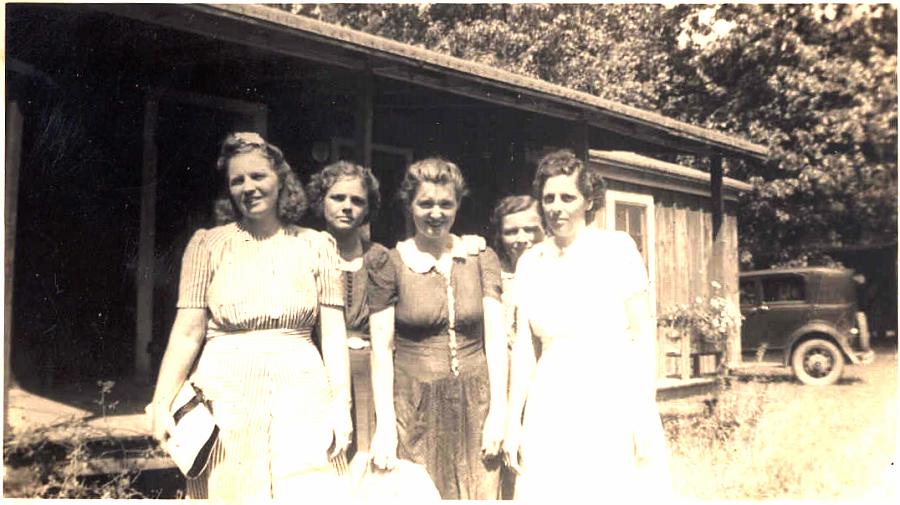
481 296 509 456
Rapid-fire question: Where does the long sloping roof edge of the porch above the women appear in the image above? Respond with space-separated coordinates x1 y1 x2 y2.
95 4 767 160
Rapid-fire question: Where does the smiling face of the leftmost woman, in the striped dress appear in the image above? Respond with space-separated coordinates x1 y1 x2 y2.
228 151 281 219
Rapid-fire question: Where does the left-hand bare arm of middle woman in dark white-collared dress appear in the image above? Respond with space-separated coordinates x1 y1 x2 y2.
369 306 397 469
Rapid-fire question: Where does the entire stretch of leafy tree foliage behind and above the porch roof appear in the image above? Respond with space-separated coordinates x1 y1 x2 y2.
282 4 897 266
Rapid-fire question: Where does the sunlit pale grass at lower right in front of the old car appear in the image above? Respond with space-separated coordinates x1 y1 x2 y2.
663 347 897 501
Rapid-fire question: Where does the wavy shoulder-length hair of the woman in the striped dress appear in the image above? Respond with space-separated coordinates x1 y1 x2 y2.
215 132 307 224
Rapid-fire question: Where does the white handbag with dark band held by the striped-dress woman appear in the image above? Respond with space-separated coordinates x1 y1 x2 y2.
164 381 219 479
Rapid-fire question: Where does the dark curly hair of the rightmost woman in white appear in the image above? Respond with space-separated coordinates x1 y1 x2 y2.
531 149 606 224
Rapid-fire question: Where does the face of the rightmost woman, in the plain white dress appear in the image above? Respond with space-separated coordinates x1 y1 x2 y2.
541 172 591 238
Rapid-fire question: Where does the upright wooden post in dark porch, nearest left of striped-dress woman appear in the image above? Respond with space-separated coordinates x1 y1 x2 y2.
134 96 159 380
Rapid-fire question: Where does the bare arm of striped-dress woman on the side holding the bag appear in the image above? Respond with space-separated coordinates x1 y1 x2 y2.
148 309 209 442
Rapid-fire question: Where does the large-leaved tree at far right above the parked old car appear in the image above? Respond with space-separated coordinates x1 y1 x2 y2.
660 5 897 266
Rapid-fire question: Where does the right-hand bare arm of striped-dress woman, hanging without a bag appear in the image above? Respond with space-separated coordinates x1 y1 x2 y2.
319 305 353 457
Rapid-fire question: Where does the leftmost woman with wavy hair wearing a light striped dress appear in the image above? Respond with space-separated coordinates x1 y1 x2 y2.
149 133 352 502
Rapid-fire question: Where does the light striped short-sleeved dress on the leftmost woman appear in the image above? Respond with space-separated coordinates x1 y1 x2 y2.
178 223 343 501
